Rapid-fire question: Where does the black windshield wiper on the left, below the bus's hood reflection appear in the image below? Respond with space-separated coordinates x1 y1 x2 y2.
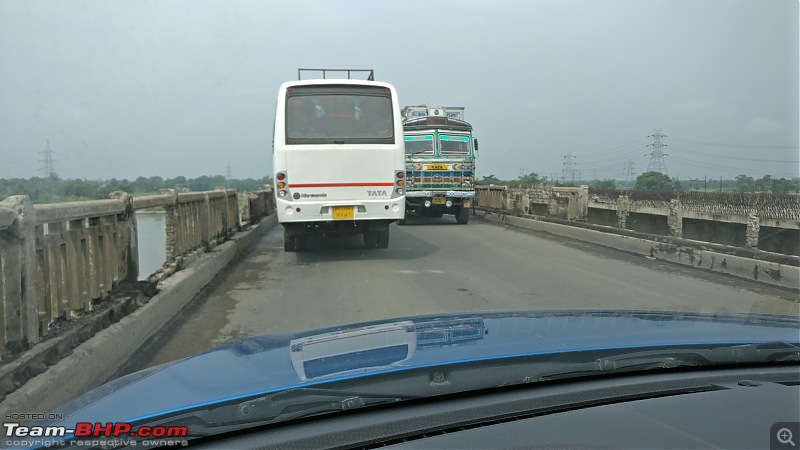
95 388 414 445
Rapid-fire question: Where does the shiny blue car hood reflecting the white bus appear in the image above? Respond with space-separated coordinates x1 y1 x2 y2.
45 310 800 425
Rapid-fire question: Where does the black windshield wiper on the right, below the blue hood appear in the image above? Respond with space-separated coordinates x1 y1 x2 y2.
524 342 800 382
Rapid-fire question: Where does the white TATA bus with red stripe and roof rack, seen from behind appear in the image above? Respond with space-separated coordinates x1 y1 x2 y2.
273 69 405 252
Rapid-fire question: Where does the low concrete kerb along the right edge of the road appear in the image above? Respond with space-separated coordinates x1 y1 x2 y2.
475 211 800 290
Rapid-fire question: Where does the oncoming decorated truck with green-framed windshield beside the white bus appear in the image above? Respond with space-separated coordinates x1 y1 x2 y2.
401 105 478 224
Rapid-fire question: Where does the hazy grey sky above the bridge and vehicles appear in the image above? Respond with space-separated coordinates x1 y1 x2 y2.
0 0 800 183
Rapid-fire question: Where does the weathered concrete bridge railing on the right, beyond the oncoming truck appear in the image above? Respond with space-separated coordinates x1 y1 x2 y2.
475 186 800 256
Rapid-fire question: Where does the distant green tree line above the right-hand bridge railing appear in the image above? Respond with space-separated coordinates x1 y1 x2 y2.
476 171 800 195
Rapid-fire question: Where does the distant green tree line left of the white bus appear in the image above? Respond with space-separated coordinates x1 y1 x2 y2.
0 175 272 203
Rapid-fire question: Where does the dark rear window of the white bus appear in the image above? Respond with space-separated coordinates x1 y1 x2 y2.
286 86 394 144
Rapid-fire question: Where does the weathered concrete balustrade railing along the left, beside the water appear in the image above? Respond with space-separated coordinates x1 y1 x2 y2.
0 187 275 351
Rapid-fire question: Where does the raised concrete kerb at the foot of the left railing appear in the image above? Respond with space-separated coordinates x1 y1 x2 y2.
0 214 277 417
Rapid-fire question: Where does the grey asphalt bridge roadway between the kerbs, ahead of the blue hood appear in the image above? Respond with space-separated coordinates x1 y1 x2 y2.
126 216 800 372
